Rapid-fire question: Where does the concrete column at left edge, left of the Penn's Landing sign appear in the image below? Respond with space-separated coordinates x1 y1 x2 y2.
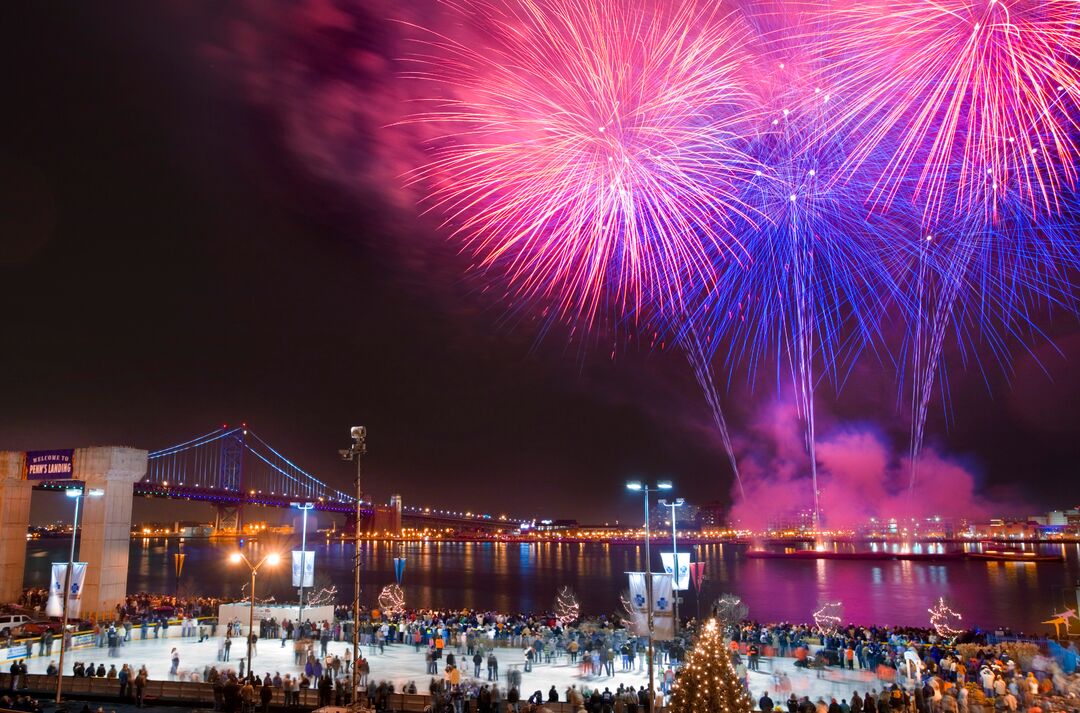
0 450 33 602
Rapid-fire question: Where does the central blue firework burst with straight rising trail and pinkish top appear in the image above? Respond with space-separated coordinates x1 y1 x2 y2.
691 38 903 524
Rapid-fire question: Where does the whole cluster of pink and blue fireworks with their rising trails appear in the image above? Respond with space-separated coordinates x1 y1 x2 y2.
409 0 1080 520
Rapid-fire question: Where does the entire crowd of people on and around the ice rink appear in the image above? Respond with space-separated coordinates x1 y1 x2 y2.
12 591 1080 713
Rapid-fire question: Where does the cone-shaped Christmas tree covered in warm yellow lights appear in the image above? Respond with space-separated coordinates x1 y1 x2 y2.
667 619 754 713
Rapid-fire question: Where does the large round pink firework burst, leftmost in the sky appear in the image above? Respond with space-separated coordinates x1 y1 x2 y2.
403 0 755 324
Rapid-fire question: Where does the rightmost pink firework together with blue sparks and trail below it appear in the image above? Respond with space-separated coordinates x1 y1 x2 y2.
807 0 1080 495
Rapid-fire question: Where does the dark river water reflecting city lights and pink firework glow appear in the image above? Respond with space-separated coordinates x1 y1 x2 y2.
19 538 1080 632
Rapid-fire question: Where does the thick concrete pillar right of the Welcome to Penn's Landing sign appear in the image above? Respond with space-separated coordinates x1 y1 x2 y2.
75 446 147 616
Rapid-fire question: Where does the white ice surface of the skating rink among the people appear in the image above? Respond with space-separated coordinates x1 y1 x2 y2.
19 638 902 703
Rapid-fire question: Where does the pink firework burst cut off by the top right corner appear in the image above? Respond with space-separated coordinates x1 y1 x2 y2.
821 0 1080 221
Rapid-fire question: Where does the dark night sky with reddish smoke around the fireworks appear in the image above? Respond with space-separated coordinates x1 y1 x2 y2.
0 2 1080 522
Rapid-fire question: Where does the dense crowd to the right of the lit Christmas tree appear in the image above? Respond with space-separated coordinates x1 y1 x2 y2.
728 621 1080 713
